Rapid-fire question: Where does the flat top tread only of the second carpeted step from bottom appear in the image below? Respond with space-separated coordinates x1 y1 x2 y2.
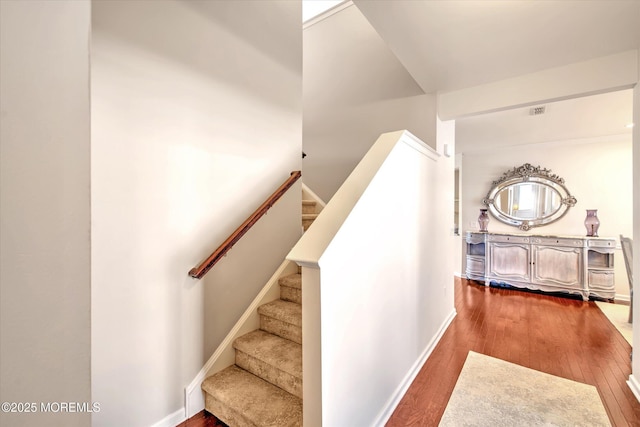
233 330 302 378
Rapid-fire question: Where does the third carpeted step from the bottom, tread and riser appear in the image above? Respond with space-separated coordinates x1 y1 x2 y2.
258 300 302 344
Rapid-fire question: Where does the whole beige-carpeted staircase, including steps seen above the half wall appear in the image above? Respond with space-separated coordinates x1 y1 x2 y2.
202 196 318 427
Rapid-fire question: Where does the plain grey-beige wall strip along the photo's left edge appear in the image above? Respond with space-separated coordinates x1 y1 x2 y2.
0 0 91 427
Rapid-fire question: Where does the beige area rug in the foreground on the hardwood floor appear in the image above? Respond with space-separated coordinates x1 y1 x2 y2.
440 351 611 427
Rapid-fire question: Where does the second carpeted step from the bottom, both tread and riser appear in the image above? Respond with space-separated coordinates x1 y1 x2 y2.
233 331 302 398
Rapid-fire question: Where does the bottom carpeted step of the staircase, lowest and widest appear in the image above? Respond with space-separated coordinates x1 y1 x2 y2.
202 365 302 427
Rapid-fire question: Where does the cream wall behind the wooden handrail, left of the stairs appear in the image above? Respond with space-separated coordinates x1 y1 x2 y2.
91 1 302 426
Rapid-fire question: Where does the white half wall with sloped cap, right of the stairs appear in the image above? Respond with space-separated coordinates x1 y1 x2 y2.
288 131 454 427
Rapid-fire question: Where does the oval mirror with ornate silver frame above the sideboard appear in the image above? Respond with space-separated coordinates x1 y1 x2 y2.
482 163 577 231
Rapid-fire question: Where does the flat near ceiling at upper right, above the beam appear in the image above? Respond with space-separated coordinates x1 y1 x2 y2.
354 0 640 93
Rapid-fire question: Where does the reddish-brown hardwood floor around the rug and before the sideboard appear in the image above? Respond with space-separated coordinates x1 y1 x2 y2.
179 278 640 427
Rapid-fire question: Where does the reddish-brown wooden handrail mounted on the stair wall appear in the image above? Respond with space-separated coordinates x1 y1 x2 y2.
189 171 302 279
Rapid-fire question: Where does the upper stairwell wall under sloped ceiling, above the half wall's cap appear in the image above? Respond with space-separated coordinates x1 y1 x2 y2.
303 2 436 201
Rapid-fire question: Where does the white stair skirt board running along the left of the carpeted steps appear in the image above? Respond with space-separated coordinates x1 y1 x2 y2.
182 260 298 420
